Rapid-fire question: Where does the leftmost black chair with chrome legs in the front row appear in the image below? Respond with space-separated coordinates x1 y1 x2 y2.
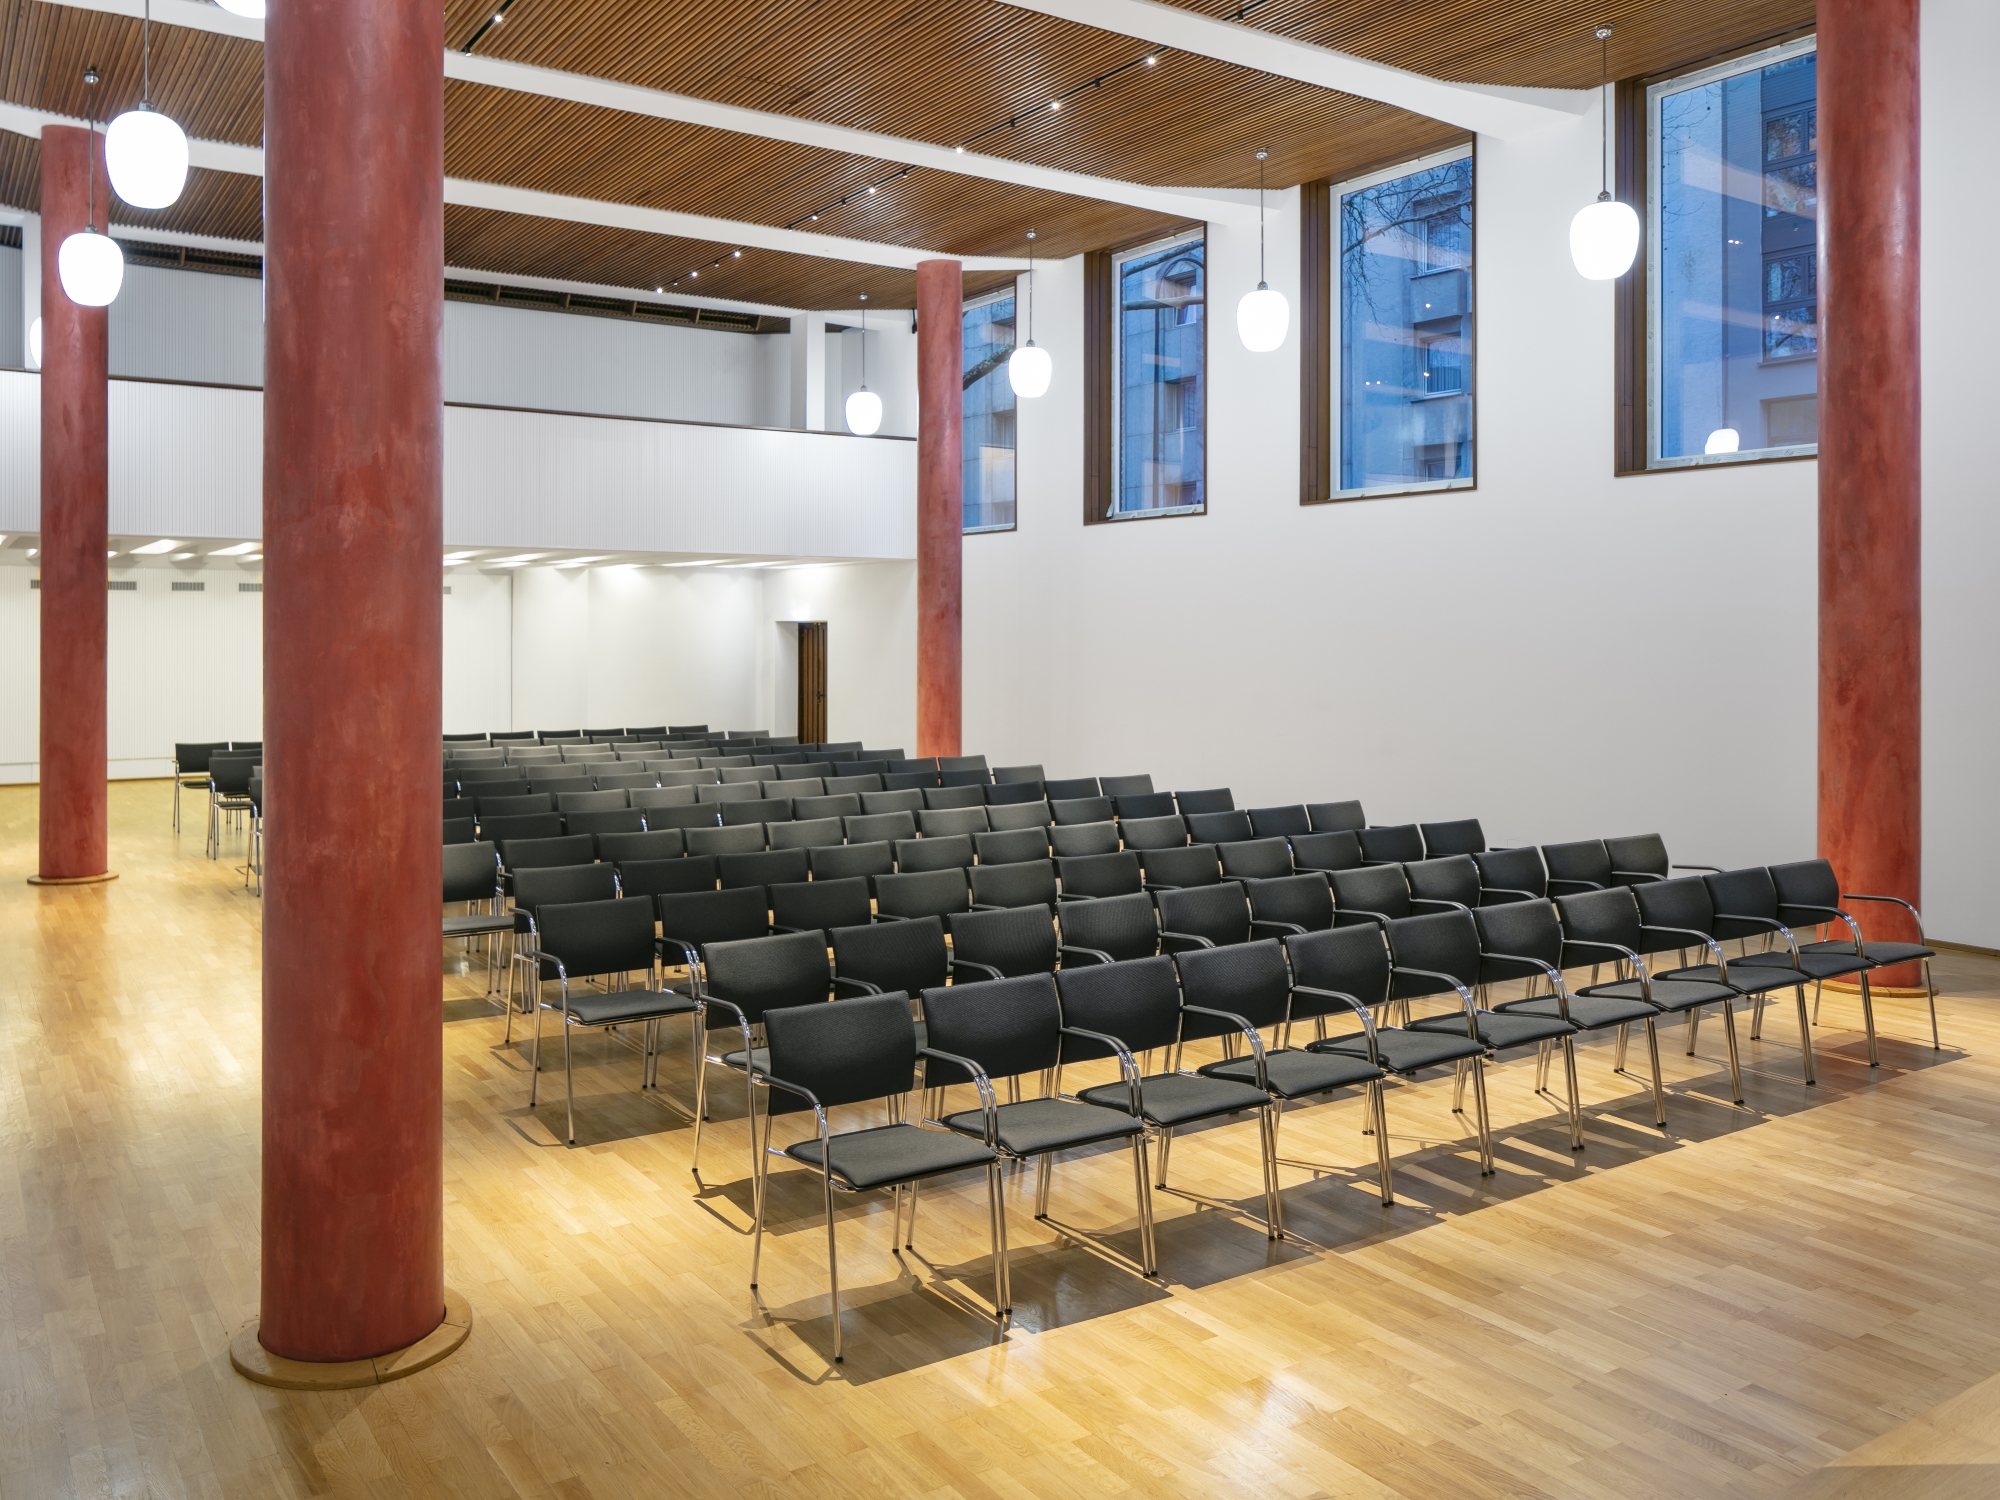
750 994 1010 1364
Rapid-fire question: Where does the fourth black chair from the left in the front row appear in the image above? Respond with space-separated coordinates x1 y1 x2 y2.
1174 952 1396 1208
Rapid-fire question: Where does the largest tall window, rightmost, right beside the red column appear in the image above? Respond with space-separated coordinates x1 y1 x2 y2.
1646 38 1820 468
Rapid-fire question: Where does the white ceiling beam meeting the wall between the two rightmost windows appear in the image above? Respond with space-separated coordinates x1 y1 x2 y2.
992 0 1590 140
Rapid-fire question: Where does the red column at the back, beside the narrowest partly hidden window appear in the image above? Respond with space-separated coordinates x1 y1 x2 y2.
916 260 966 756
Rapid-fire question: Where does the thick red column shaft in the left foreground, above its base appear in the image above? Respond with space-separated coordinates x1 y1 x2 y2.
258 0 444 1360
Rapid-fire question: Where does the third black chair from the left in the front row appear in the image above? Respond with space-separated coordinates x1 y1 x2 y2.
1056 958 1284 1240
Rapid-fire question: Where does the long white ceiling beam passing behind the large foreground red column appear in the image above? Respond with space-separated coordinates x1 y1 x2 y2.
52 0 1256 224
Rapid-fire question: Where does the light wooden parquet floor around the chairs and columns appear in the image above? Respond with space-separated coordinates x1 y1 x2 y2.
0 782 2000 1500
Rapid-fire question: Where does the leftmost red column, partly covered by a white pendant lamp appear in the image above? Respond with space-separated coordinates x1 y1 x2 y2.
40 126 110 880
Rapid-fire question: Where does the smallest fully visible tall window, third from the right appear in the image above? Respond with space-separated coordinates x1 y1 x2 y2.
1108 230 1208 520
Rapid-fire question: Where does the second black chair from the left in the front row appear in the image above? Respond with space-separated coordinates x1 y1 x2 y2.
924 974 1156 1276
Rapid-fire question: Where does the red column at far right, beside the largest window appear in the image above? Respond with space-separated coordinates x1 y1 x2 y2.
1818 0 1924 984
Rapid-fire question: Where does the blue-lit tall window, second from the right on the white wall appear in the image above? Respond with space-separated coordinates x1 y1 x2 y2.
1334 146 1472 496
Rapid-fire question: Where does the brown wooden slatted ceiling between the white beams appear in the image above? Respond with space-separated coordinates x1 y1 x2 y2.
0 0 1812 306
